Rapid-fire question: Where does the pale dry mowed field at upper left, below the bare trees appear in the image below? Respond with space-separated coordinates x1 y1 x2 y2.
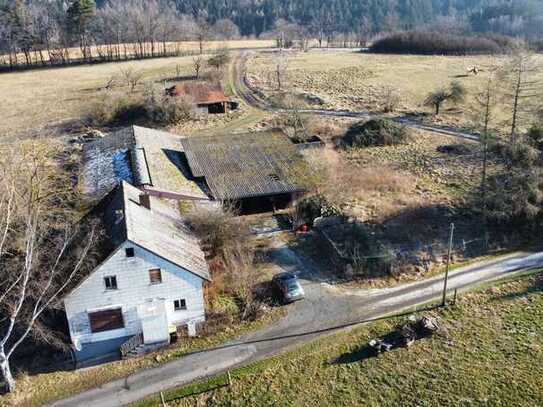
0 41 269 137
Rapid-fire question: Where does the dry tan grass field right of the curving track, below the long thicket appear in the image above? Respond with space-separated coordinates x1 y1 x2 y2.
247 51 543 134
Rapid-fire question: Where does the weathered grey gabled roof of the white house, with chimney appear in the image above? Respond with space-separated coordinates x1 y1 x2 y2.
100 181 210 280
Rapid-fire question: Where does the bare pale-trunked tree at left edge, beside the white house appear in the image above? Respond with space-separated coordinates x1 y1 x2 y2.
0 143 97 391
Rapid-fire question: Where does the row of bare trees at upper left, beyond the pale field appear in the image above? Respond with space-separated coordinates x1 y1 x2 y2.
0 0 240 68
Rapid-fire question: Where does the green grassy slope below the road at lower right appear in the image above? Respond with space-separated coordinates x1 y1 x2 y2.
140 276 543 406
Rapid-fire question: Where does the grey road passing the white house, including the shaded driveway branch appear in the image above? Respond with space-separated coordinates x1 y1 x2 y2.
51 241 543 407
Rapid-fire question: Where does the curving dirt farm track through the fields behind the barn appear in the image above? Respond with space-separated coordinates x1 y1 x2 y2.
234 52 479 141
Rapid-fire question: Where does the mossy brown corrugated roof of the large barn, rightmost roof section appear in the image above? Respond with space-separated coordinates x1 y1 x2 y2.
181 130 307 200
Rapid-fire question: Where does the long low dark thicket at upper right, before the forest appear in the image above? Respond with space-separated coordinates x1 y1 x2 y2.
371 31 514 55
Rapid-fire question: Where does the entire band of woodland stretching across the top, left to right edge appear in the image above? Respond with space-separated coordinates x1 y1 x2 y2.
0 0 543 68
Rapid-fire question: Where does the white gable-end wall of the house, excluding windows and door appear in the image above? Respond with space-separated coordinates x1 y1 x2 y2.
64 242 204 344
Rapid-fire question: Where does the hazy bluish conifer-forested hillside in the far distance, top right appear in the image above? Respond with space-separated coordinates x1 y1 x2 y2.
167 0 543 35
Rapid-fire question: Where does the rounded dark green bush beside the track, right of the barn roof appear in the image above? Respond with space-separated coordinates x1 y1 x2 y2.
342 119 409 148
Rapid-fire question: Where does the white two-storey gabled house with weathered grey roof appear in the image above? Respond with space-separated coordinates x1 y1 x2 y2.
64 182 210 363
